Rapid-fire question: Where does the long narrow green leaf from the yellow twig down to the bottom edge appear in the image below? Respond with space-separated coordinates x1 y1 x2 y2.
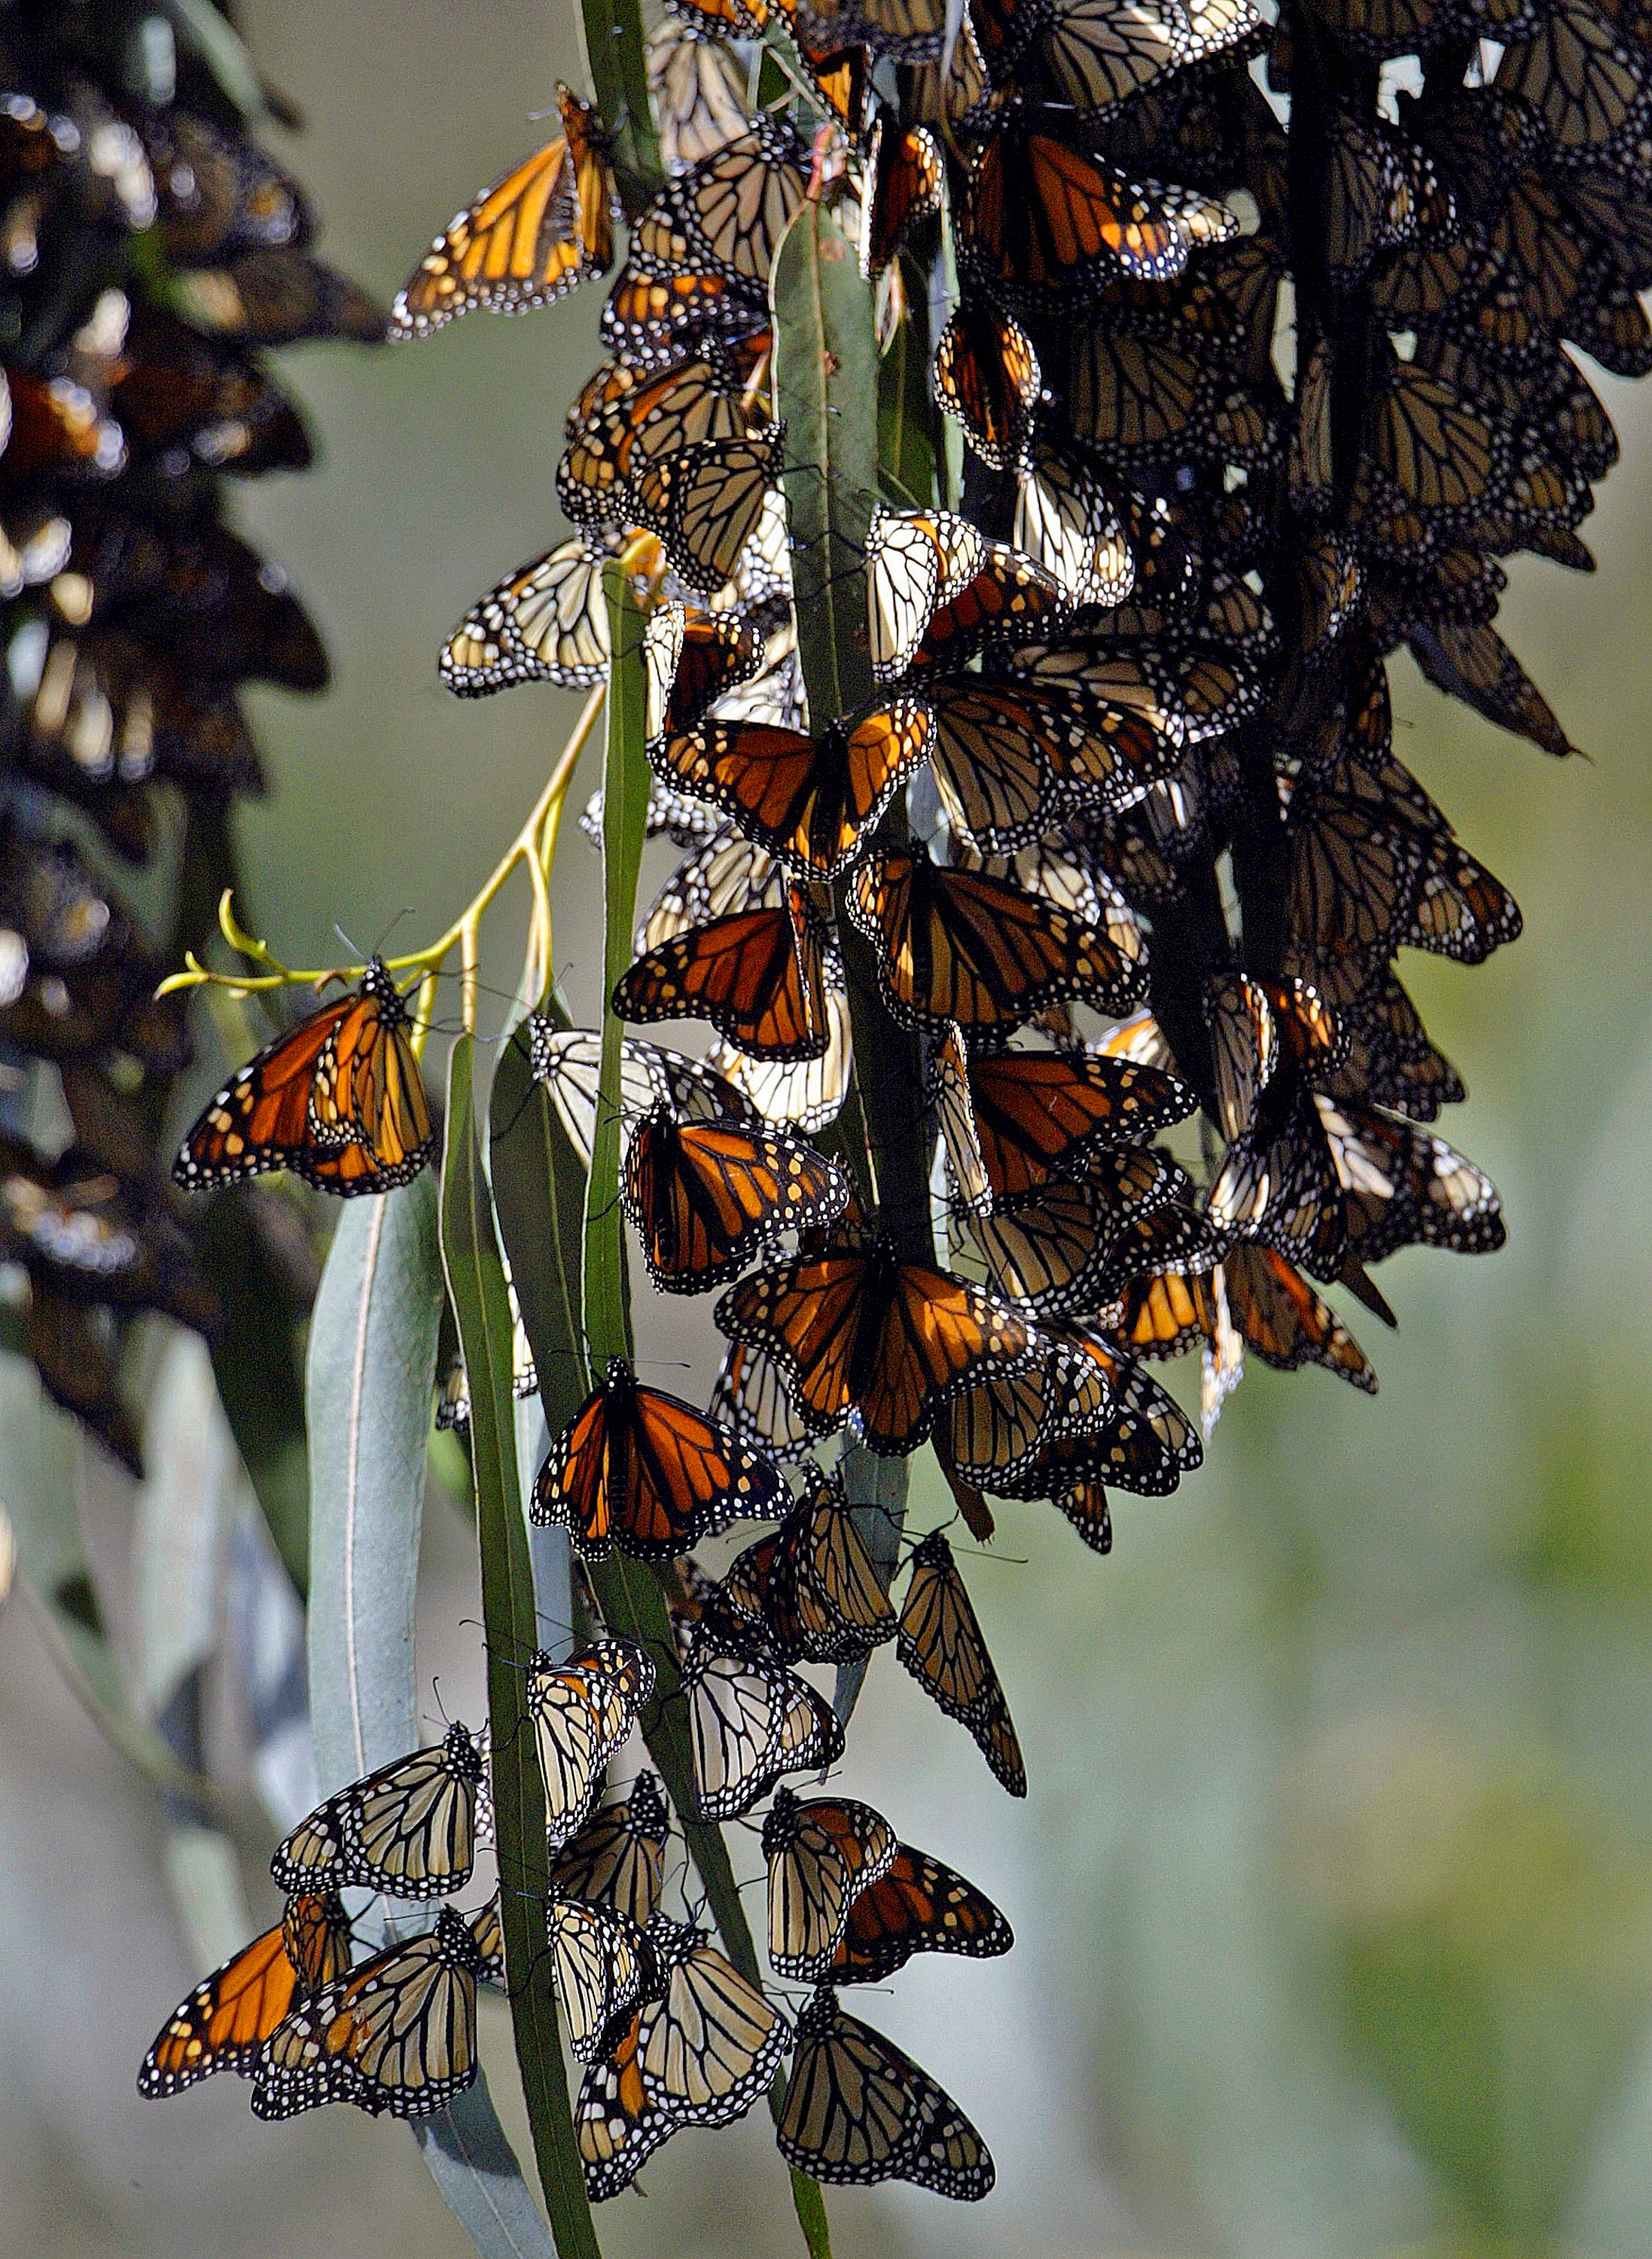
440 1035 599 2259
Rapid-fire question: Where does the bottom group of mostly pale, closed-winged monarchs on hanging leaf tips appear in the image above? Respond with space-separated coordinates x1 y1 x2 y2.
138 1617 1013 2200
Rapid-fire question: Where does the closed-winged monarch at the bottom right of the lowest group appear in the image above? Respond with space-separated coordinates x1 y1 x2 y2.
775 1988 997 2203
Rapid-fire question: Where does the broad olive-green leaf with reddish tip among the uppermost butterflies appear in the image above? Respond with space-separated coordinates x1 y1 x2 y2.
770 201 877 730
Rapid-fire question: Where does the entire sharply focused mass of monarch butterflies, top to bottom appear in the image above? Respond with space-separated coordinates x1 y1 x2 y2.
145 0 1652 2196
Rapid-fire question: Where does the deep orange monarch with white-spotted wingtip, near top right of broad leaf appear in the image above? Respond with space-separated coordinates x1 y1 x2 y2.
968 120 1211 300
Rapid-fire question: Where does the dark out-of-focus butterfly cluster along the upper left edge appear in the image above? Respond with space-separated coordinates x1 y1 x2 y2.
0 5 384 1471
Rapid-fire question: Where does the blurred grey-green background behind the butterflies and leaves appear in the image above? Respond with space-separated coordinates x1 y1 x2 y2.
0 0 1652 2259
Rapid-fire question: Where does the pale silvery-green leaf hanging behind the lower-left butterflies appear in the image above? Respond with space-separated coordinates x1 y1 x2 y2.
309 1175 556 2259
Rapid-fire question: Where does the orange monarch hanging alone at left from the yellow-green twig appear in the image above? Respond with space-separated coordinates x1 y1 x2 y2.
172 958 436 1200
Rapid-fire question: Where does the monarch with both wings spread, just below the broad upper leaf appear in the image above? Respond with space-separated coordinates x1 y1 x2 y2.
653 698 931 881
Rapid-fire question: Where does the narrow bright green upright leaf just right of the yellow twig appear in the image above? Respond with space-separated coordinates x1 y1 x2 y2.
585 558 651 1376
